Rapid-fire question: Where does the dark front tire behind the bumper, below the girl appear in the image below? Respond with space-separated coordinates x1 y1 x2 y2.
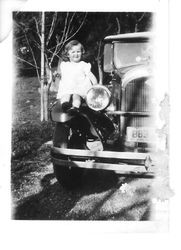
53 123 84 189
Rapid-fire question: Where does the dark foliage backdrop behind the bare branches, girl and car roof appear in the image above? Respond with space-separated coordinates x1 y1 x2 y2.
13 12 154 76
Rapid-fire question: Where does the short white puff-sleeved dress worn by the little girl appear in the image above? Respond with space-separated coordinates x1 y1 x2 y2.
57 61 92 99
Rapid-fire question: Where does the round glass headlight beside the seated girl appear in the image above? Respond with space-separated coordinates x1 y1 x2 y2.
86 85 111 111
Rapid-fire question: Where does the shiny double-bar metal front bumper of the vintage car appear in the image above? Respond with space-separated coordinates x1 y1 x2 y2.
51 147 154 175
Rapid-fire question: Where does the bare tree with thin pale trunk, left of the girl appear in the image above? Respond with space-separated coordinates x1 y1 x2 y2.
15 12 87 121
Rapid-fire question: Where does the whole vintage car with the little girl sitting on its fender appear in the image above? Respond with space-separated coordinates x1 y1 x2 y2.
50 32 156 186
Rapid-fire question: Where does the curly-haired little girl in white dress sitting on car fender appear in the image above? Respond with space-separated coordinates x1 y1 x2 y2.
57 40 97 111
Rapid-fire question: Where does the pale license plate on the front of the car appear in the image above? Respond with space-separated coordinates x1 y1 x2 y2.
127 127 155 142
